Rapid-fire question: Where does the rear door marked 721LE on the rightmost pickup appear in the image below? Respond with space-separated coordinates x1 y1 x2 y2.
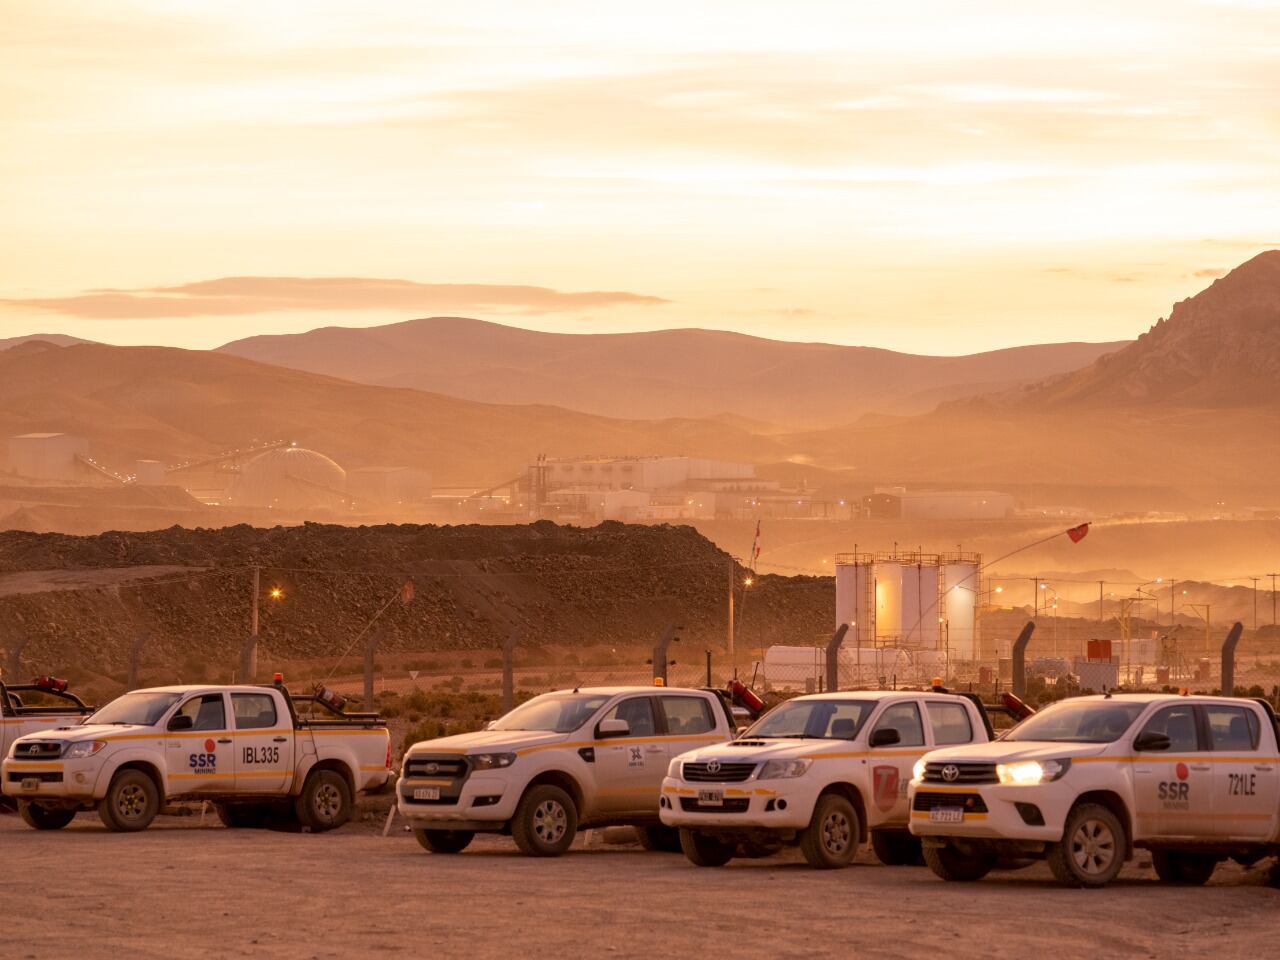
1201 703 1280 840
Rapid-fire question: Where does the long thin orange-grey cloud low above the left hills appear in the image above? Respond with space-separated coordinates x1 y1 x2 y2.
0 276 668 320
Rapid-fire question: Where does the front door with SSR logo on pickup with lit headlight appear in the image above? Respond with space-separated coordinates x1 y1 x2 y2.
1132 703 1213 837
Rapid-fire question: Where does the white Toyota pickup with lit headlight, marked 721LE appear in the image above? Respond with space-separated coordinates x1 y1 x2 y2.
910 694 1280 887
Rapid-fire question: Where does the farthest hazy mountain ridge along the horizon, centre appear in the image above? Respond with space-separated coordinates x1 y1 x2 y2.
220 316 1124 428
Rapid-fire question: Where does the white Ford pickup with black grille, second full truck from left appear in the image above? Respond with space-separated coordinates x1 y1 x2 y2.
396 686 733 856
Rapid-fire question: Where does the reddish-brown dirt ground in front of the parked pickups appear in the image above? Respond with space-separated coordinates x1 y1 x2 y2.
0 814 1280 960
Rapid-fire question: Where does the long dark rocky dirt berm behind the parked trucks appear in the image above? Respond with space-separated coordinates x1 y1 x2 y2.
0 521 835 671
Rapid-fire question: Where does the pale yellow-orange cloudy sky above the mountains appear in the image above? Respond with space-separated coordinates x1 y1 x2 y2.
0 0 1280 353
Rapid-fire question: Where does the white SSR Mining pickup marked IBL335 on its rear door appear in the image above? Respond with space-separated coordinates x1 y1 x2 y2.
0 685 390 831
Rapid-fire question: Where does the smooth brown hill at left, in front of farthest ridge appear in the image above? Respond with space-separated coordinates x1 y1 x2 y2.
0 344 781 484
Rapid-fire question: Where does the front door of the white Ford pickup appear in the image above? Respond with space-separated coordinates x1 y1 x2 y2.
595 696 667 817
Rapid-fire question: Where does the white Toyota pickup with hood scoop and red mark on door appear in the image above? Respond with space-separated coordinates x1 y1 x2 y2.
659 690 992 869
